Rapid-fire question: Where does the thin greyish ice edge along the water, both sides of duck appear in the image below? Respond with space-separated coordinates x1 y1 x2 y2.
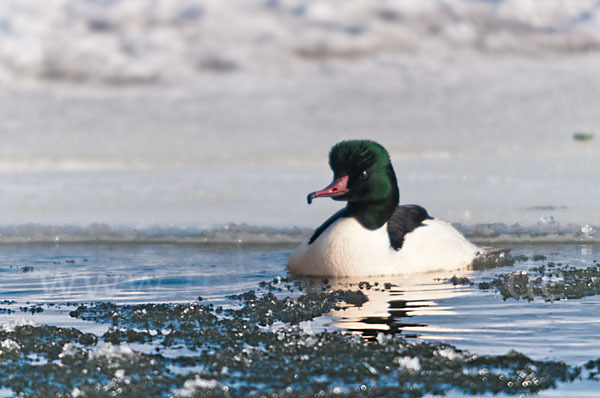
0 220 600 245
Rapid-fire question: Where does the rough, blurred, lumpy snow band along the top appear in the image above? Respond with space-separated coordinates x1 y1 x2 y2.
0 0 600 84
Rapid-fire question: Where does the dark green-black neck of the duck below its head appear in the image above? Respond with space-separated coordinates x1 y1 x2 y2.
345 170 400 230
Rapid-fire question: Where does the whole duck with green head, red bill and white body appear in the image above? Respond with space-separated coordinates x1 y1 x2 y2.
287 140 479 277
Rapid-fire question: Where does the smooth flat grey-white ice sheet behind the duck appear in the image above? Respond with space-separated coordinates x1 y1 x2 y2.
0 55 600 232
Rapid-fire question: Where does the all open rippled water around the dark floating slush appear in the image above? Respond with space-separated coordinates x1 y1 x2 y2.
0 244 600 396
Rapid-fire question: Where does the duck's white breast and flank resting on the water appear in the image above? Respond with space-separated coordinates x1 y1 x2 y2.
287 217 478 276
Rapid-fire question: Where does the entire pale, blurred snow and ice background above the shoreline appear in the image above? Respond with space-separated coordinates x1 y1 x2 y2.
0 0 600 238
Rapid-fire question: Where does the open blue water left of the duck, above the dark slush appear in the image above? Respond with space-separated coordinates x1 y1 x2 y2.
2 244 287 303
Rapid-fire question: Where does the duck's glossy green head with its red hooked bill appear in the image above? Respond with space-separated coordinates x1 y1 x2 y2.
308 140 400 226
